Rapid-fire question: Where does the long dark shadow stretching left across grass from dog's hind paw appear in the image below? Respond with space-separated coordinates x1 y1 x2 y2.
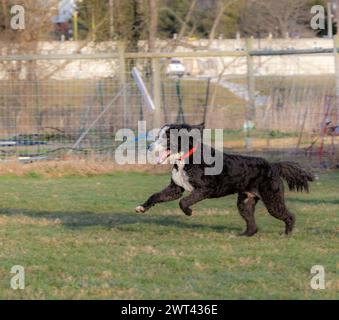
0 208 241 232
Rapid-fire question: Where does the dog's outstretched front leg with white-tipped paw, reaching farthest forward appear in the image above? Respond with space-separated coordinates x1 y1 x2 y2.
135 181 184 213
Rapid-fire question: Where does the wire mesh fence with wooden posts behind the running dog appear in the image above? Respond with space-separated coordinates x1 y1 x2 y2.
0 48 339 166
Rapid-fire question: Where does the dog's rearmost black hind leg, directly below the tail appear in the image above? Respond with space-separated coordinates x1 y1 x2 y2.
260 178 295 234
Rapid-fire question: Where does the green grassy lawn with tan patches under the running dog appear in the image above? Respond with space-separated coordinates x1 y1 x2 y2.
0 172 339 299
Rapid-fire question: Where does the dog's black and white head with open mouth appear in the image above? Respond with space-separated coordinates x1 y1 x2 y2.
148 123 204 164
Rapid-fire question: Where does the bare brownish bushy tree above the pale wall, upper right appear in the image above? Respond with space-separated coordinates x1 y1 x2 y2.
240 0 312 37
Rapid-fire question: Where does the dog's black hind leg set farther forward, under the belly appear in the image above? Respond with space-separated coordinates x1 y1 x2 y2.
237 193 259 237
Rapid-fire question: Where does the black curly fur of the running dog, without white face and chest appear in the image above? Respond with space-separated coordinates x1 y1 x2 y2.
136 125 314 236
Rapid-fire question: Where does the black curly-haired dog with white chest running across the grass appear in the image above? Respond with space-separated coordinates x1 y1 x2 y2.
136 124 314 236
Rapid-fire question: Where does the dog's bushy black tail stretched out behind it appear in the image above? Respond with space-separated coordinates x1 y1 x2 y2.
271 161 315 192
